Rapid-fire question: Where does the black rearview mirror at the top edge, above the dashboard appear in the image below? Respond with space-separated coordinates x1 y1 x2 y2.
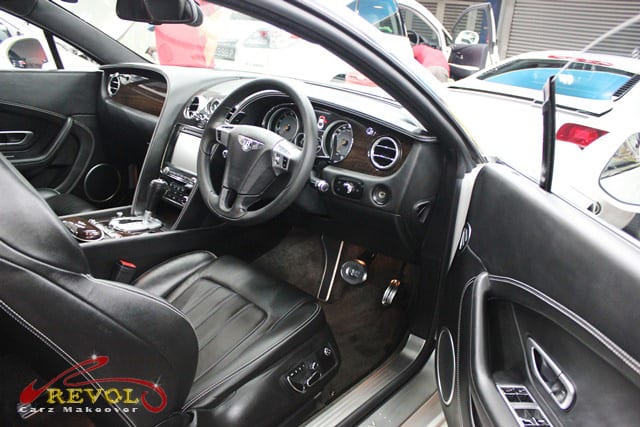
116 0 202 27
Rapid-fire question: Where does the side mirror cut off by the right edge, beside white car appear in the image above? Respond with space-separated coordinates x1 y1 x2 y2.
600 133 640 206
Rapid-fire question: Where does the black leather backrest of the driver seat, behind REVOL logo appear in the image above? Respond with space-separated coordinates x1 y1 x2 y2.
0 154 197 425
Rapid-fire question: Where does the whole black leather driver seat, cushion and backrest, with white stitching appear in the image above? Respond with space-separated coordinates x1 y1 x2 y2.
0 155 339 426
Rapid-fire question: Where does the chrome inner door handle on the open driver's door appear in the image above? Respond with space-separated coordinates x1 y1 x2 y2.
527 338 576 411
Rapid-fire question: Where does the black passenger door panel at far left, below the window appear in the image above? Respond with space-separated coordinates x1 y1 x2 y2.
0 70 101 195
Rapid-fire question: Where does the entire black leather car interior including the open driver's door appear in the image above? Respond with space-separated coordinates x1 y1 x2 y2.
0 0 640 426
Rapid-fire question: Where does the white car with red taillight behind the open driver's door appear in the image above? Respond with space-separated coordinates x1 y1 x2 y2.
449 51 640 232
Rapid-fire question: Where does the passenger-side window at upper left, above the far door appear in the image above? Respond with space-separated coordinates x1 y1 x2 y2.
0 11 98 70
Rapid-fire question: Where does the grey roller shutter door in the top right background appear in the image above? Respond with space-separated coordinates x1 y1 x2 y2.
507 0 640 56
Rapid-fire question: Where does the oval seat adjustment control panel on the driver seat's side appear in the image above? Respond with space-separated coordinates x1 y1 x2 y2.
283 344 338 393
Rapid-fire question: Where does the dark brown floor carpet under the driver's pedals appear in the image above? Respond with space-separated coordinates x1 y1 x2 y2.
254 228 415 398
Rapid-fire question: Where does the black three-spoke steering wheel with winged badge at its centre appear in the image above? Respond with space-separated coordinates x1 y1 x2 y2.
198 78 318 225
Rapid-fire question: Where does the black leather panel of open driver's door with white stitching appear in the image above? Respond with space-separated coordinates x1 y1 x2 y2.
441 165 640 426
